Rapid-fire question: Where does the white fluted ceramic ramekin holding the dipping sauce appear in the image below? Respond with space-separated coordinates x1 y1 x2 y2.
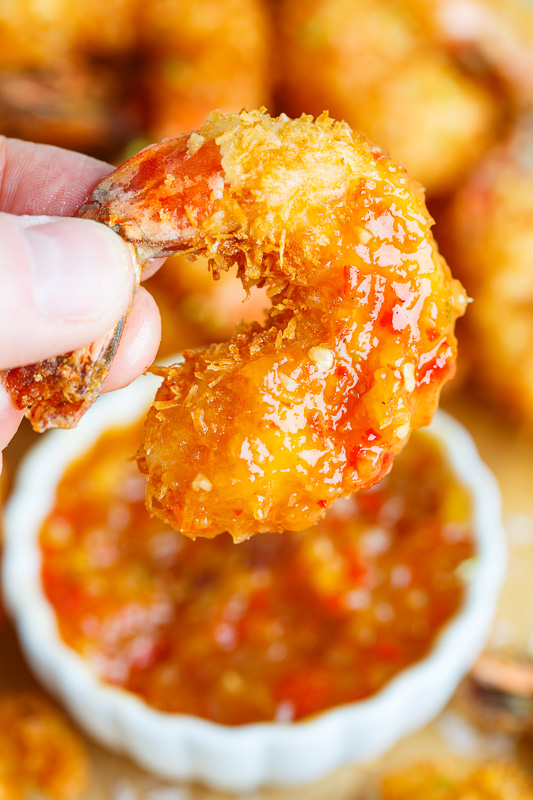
3 376 505 791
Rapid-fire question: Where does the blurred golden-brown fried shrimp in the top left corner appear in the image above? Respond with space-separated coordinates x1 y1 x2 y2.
0 0 140 154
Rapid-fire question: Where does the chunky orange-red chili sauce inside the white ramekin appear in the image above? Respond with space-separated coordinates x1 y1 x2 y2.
41 427 474 725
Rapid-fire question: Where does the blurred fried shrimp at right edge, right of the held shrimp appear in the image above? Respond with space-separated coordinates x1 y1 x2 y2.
442 120 533 425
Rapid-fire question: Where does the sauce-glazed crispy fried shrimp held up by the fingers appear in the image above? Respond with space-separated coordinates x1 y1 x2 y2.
77 111 466 541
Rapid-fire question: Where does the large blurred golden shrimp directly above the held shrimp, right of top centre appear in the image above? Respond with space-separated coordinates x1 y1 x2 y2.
279 0 494 195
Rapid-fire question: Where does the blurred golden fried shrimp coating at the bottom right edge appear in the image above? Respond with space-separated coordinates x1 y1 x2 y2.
380 762 533 800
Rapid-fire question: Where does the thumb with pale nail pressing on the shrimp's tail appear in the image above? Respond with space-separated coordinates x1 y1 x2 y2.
0 208 134 369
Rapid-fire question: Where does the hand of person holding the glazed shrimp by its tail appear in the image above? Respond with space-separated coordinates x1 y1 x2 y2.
0 137 161 470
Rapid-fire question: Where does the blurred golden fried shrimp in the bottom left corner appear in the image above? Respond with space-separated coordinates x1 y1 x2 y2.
0 692 89 800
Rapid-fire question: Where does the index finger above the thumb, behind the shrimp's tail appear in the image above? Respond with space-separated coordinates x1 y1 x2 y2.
0 136 113 217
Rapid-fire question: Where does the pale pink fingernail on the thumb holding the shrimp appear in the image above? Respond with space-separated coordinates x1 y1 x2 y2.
24 218 133 321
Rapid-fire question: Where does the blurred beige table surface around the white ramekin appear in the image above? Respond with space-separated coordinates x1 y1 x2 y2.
0 396 533 800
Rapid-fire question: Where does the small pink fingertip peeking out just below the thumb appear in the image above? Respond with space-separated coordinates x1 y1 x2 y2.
103 286 161 392
